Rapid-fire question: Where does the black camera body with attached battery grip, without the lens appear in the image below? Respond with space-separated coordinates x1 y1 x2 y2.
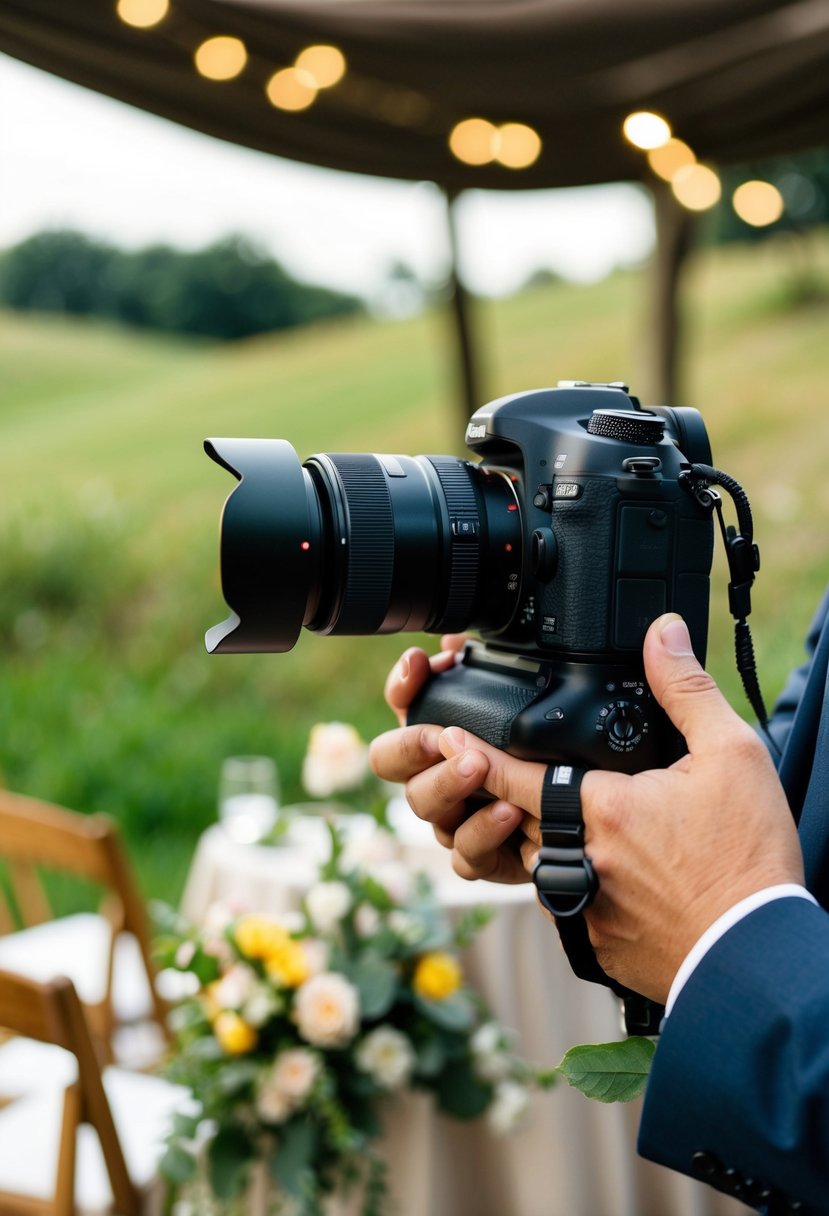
410 382 714 772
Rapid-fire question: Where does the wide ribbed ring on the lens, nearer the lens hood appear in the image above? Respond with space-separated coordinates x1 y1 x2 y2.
331 452 394 634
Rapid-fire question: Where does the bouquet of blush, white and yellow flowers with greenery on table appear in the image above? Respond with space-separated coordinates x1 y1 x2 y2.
158 824 556 1216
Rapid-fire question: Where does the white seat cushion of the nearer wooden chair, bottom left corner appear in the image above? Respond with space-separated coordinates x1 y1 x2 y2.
0 1068 193 1216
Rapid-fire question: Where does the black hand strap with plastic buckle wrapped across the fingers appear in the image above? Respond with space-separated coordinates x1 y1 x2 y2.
532 765 664 1035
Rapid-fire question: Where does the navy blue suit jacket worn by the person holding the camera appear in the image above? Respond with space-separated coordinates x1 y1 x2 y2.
639 583 829 1214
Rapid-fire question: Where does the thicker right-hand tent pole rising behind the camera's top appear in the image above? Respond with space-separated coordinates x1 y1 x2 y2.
650 181 694 405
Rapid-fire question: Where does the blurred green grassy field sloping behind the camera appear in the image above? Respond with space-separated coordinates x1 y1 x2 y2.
0 233 829 899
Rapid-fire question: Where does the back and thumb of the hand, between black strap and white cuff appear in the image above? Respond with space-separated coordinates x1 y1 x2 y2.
581 614 803 1002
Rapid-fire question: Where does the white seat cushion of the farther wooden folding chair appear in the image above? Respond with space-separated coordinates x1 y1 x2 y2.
0 912 152 1021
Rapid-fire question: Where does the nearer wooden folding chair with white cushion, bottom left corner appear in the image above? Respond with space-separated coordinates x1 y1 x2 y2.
0 972 190 1216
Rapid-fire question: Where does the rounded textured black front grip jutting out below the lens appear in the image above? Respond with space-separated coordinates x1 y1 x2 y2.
407 664 538 750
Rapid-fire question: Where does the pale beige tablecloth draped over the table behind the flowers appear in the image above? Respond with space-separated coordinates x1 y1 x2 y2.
182 821 748 1216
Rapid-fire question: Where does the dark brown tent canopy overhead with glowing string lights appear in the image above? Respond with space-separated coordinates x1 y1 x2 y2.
0 0 829 193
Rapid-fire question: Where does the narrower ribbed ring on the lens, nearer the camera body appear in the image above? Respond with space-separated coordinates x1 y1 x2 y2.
430 456 481 632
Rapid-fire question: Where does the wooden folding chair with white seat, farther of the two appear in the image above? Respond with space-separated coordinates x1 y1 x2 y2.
0 790 169 1059
